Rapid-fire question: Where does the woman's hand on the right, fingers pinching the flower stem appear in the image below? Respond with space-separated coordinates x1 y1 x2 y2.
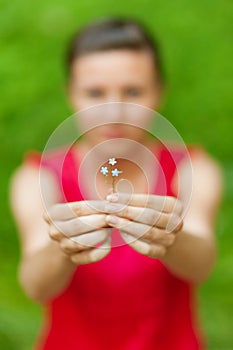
106 193 183 258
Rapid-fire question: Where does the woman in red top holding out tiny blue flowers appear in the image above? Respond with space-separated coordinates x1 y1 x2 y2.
11 19 221 350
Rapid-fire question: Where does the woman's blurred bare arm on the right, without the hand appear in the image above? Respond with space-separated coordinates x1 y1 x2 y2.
161 151 222 283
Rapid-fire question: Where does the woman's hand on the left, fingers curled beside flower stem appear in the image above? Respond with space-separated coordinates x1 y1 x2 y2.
44 201 112 265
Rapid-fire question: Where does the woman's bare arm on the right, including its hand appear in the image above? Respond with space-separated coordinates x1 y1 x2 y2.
104 152 222 283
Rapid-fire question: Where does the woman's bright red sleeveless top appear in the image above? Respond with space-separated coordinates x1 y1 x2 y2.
27 144 204 350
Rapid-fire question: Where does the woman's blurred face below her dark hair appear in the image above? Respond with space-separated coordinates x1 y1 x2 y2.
69 49 161 145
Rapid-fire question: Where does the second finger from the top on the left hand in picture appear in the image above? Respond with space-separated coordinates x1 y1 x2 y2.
56 214 108 237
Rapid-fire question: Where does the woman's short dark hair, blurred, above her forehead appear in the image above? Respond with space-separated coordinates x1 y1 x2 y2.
67 17 164 83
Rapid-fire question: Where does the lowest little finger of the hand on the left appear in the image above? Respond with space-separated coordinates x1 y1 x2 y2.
71 237 111 265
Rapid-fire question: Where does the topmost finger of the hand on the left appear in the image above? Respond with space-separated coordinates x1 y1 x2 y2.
47 200 107 221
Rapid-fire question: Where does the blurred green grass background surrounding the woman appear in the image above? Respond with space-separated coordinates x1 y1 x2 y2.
0 0 233 350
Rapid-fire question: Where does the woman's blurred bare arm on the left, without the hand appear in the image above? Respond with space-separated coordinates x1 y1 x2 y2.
11 165 75 302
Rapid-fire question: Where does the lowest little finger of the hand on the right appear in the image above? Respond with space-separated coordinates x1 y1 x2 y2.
121 232 167 258
